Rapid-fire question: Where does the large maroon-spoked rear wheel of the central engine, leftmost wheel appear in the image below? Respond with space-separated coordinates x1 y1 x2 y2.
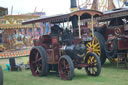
29 46 48 76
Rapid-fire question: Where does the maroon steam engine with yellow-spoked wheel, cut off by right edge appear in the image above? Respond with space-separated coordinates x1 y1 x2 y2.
87 8 128 65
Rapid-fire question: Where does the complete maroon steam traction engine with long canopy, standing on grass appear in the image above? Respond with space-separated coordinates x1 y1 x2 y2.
23 10 102 80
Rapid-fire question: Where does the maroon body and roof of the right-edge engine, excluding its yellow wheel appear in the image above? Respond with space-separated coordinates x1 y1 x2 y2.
96 8 128 62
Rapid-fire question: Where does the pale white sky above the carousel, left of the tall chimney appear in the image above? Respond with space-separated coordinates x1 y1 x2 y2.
0 0 125 16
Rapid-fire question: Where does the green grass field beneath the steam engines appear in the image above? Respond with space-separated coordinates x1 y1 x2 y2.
0 59 128 85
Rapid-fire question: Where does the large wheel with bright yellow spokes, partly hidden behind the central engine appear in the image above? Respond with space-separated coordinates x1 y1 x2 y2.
86 32 106 64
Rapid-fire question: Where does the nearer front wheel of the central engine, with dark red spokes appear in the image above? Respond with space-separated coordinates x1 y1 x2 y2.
58 55 74 80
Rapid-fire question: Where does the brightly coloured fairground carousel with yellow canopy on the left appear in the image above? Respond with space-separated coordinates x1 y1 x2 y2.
0 14 41 58
